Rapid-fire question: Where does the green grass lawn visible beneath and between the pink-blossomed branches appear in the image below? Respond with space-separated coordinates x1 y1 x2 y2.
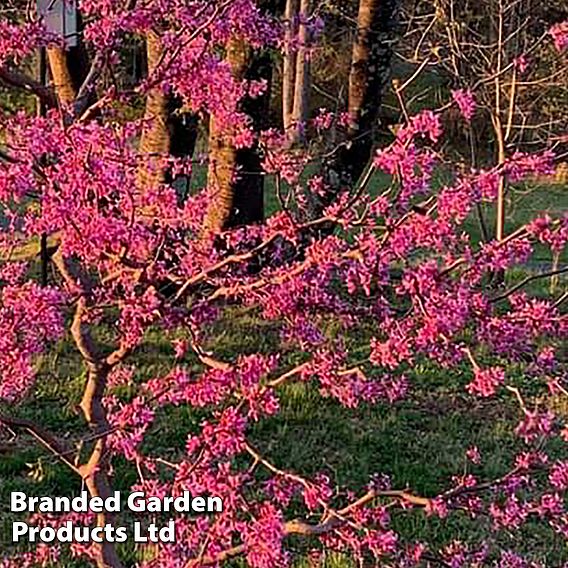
0 176 568 568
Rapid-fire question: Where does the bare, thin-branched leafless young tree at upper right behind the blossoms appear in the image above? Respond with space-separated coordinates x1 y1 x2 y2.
405 0 567 240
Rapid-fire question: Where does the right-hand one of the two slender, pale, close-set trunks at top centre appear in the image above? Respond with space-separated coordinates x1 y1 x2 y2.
291 0 310 143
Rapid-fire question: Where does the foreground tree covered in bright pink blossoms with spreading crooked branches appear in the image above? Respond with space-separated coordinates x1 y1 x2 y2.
0 0 568 568
